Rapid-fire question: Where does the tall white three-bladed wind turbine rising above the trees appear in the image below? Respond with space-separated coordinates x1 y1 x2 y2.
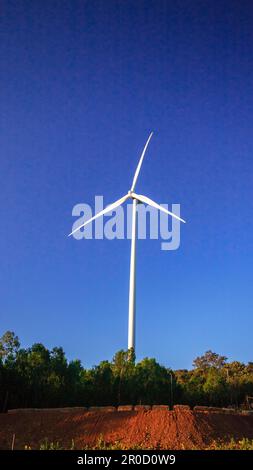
68 132 185 350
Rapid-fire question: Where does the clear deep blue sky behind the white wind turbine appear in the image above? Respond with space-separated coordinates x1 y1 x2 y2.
0 0 253 368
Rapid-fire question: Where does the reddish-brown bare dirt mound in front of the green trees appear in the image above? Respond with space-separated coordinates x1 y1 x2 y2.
0 407 253 449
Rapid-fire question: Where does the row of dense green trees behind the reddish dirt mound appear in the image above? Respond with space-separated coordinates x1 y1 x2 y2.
0 331 253 412
